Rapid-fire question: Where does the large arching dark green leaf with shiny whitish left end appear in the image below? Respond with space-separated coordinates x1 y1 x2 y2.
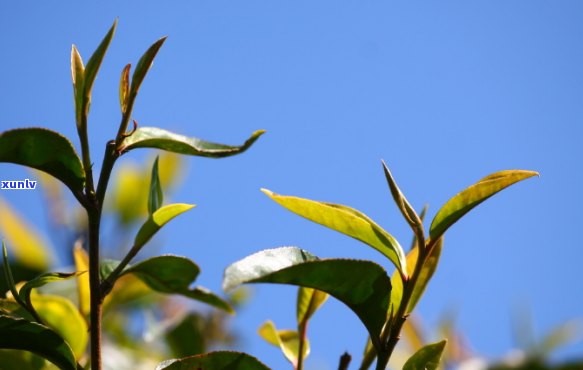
223 247 391 349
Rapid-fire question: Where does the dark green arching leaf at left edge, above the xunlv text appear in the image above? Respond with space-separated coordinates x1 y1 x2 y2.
0 128 85 196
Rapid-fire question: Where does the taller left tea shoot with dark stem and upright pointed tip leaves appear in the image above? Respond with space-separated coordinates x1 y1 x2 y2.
0 21 264 370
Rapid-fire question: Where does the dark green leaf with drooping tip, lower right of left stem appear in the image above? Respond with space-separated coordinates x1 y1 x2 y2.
120 255 234 313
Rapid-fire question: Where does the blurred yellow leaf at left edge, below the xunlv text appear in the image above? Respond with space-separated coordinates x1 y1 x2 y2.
0 198 52 271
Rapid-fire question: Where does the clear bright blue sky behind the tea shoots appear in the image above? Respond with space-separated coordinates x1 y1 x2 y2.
0 0 583 369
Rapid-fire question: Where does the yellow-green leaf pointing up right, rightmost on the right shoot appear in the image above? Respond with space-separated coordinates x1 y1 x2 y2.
429 170 538 241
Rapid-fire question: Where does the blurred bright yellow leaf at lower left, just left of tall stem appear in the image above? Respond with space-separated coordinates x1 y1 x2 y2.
32 289 89 358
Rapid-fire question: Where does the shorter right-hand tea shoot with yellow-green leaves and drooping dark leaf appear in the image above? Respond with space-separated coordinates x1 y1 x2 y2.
223 163 537 370
